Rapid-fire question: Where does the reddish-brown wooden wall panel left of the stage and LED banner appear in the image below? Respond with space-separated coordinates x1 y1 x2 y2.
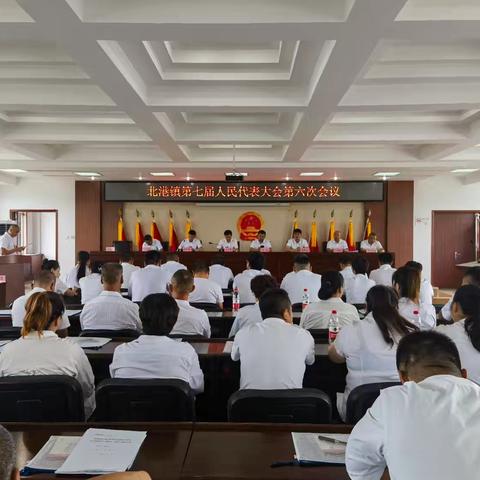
75 182 102 252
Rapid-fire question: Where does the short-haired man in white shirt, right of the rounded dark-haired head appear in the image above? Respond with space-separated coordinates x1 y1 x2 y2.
170 270 211 338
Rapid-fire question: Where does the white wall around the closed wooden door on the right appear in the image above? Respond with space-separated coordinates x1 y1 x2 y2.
413 175 480 278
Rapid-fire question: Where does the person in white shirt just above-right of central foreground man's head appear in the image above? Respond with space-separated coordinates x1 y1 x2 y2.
280 254 322 305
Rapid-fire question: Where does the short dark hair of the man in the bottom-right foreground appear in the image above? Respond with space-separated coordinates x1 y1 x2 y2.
397 330 462 372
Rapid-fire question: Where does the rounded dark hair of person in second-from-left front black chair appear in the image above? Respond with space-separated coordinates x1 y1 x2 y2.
139 293 179 335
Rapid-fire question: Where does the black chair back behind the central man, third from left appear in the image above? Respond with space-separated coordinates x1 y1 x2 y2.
228 388 332 423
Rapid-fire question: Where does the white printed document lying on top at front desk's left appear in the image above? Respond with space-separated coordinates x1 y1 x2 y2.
55 428 147 475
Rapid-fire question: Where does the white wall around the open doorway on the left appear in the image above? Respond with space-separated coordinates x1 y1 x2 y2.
0 177 75 274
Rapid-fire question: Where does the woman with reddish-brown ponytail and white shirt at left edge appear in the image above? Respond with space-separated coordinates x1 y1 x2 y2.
0 290 95 419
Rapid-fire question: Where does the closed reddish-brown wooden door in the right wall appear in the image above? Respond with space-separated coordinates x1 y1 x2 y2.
432 211 475 288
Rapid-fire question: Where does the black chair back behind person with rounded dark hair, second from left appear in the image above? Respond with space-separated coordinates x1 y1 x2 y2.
94 378 195 422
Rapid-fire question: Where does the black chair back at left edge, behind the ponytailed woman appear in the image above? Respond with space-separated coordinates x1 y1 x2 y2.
0 375 85 422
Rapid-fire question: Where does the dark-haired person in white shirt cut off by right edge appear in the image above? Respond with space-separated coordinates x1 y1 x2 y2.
436 285 480 385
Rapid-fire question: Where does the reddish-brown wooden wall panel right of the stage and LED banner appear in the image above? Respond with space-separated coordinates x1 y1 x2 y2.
387 181 413 267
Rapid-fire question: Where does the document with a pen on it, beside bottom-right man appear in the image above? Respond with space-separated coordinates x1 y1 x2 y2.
292 432 349 465
